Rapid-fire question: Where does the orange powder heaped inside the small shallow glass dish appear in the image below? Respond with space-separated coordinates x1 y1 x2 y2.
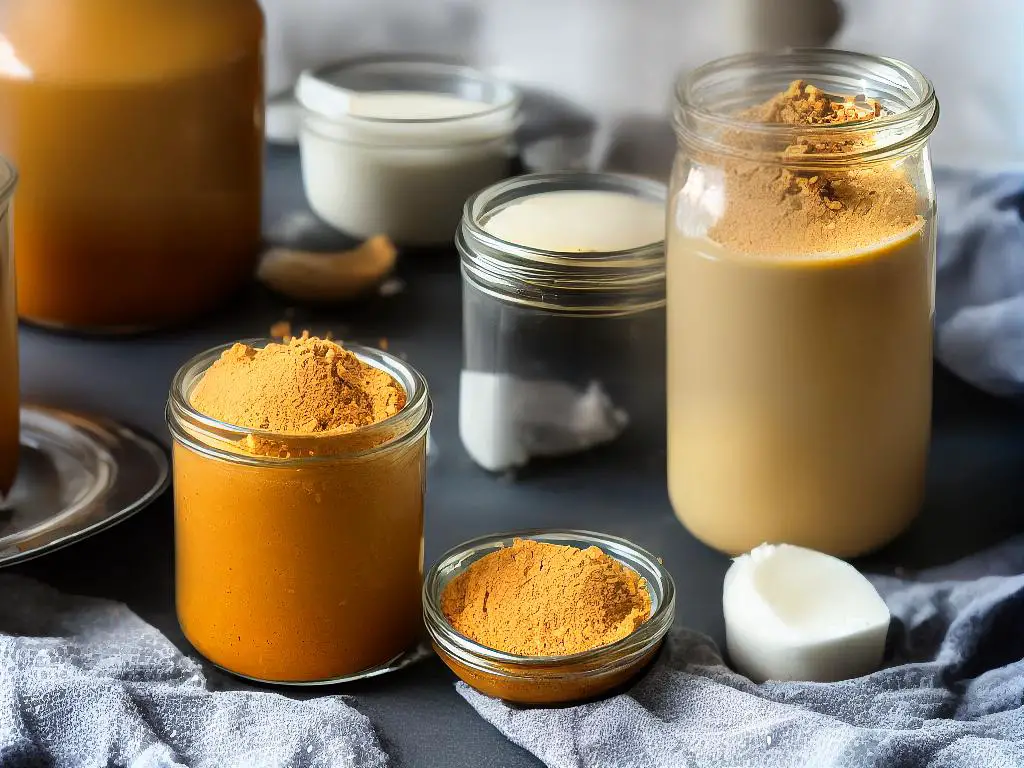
441 539 651 656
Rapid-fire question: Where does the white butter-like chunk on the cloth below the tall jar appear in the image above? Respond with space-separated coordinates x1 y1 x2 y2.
722 544 889 682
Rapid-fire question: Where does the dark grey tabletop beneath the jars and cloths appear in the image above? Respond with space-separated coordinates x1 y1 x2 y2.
17 145 1024 768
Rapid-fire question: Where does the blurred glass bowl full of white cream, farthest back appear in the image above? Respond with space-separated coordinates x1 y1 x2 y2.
296 58 520 247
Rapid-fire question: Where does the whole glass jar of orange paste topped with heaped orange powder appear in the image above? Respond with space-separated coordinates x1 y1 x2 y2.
167 336 432 684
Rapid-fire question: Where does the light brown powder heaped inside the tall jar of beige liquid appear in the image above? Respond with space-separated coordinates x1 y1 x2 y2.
709 80 921 256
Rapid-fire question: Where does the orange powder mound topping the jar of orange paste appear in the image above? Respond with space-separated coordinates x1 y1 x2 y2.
190 334 406 434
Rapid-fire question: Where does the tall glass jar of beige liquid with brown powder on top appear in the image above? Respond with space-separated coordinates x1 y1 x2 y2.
667 49 938 556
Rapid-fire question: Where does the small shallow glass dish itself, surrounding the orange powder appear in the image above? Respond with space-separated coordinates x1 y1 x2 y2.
423 530 676 706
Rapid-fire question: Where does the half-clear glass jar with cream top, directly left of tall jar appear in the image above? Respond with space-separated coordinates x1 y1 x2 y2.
456 172 666 472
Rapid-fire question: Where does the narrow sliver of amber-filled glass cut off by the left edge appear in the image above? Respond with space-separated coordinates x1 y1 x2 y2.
0 158 19 499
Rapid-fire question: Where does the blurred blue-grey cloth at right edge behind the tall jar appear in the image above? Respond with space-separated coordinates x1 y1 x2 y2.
935 168 1024 395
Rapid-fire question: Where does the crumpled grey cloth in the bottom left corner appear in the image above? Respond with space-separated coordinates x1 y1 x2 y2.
0 574 388 768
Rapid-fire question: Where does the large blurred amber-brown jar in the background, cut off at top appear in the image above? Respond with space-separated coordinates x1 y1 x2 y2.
0 0 263 332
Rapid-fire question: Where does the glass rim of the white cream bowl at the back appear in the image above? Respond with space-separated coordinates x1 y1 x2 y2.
295 55 522 126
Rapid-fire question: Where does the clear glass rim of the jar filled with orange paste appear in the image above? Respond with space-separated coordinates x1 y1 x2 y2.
165 338 433 466
